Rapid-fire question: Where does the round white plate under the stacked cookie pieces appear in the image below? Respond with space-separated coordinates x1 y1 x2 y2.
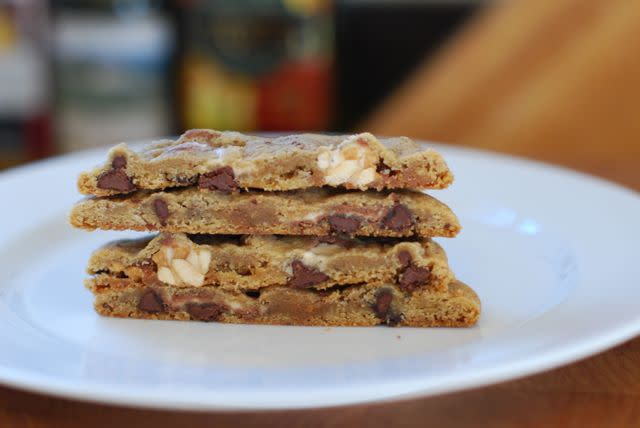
0 142 640 409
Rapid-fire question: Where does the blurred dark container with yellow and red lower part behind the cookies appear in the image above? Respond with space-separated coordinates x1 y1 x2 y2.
178 0 333 131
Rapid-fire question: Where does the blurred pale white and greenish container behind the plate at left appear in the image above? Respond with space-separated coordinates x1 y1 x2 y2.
54 0 175 151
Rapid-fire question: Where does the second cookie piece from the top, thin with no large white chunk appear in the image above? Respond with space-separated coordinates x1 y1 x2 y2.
70 187 460 237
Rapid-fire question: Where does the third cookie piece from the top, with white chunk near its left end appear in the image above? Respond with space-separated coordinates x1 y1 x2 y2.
87 233 453 291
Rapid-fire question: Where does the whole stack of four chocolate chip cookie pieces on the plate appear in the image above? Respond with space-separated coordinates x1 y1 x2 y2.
70 130 480 326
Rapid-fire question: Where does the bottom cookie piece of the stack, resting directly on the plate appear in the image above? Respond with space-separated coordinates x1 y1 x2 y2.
86 276 480 327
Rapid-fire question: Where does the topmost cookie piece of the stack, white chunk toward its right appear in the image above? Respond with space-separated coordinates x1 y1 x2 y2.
78 129 453 196
